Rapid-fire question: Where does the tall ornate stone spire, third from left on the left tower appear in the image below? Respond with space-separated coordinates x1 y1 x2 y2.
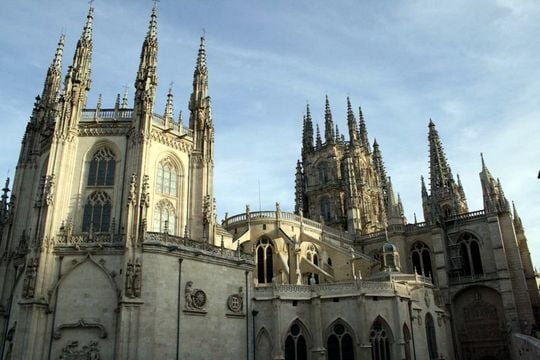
134 5 158 134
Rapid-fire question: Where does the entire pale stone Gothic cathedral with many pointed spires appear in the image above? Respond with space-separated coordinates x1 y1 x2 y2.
0 6 540 360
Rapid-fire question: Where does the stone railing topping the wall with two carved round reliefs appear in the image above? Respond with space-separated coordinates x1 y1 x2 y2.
144 232 254 262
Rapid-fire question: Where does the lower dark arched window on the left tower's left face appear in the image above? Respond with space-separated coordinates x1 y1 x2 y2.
82 191 112 232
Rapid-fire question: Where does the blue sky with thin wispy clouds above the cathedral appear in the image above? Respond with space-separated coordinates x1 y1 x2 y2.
0 0 540 265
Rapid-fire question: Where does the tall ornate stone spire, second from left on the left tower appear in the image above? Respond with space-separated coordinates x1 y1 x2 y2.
57 7 94 136
